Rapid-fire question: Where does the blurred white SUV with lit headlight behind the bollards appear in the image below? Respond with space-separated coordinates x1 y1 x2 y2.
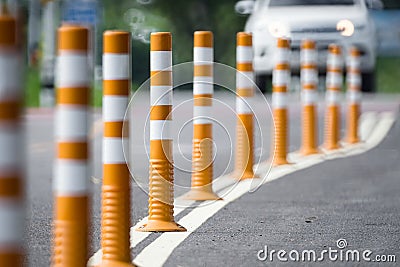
235 0 382 91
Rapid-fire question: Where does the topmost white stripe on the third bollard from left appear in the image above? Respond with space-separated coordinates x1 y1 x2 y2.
103 53 130 80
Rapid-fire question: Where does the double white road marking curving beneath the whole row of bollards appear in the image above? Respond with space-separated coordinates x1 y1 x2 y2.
88 112 395 266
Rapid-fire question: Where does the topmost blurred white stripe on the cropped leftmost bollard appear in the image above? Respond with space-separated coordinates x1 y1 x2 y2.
0 51 19 94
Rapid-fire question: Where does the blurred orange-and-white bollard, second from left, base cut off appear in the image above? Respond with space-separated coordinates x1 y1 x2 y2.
52 25 90 267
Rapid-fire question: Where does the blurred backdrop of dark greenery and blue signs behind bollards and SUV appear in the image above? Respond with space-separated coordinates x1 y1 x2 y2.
20 0 400 107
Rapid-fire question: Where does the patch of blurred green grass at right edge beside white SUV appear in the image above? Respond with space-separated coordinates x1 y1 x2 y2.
376 57 400 93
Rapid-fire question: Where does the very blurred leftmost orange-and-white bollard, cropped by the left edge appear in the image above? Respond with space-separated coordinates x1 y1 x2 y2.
0 8 26 266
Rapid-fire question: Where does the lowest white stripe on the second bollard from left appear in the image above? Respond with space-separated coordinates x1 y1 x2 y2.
53 159 89 196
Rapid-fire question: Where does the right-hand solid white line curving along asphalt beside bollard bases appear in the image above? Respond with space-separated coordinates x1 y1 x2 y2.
134 113 395 266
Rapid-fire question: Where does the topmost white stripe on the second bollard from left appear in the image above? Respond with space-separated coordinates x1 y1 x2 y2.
56 53 90 87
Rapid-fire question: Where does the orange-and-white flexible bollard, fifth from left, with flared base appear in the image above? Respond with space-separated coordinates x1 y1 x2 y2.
185 31 220 200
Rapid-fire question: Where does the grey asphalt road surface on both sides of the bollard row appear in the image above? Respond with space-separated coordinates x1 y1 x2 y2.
25 92 400 266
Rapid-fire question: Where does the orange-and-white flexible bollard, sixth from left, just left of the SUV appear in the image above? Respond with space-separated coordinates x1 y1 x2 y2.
234 32 255 179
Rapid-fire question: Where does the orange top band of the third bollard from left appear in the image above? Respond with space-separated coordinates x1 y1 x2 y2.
103 30 131 54
